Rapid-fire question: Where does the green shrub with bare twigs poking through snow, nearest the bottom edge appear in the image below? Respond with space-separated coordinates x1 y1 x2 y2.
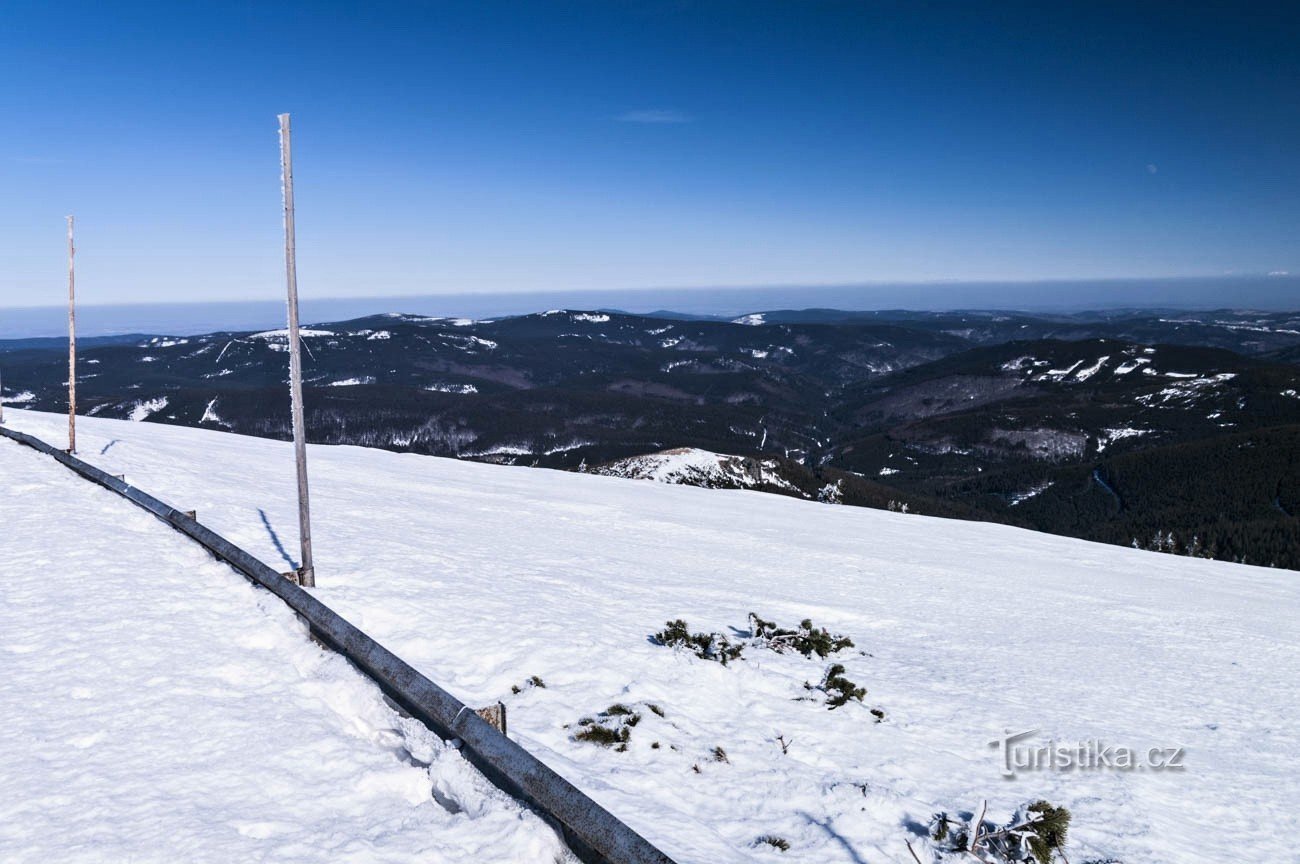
930 800 1070 864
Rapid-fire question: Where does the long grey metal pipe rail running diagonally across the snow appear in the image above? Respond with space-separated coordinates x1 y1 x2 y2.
0 426 673 864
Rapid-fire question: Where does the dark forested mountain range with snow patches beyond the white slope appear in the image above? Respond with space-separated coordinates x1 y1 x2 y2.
0 309 1300 568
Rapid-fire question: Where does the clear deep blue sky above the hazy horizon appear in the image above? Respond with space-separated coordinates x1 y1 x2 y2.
0 0 1300 305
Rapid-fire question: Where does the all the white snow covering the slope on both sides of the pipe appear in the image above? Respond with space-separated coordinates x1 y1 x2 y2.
0 411 1300 864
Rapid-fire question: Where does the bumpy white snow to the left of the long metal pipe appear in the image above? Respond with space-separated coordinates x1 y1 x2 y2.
0 428 567 864
